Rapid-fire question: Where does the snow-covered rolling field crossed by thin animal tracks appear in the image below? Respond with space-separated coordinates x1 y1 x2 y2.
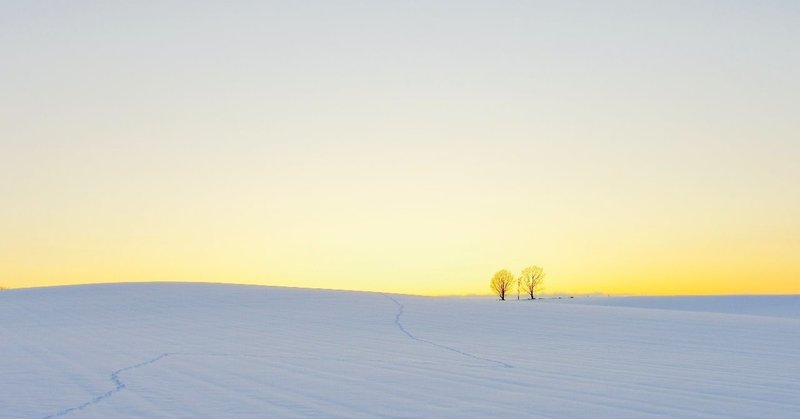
0 283 800 418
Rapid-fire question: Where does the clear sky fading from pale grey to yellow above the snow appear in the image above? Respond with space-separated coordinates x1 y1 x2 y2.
0 0 800 294
